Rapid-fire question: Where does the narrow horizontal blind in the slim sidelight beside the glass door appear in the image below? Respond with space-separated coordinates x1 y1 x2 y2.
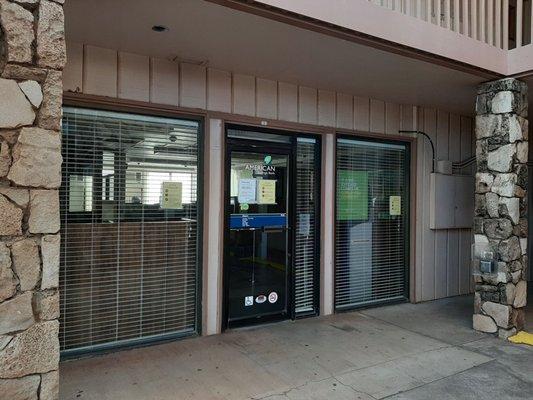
294 138 319 315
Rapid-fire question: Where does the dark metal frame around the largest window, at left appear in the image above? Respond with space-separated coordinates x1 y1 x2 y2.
59 97 206 361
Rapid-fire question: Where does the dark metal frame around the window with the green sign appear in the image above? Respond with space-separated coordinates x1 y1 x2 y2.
333 132 413 313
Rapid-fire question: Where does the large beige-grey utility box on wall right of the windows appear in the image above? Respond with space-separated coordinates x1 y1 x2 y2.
429 173 475 229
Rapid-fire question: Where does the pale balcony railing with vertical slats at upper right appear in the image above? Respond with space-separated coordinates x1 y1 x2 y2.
369 0 533 50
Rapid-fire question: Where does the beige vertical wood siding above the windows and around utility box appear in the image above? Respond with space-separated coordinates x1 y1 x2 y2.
64 43 474 301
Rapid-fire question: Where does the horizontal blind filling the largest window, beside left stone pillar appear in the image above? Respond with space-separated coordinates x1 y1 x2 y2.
60 107 199 351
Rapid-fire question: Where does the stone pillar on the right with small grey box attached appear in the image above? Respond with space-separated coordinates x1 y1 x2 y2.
473 79 528 338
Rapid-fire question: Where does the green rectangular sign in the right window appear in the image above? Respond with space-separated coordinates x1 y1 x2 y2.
337 170 368 221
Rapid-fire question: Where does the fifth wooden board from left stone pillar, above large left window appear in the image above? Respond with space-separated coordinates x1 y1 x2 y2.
179 63 207 109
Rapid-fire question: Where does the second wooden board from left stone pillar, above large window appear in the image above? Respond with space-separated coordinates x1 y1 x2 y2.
83 46 118 97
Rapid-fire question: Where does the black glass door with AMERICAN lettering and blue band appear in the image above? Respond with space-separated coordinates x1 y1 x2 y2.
225 145 290 326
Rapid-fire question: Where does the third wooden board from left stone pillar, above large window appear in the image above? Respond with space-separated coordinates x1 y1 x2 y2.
118 52 150 101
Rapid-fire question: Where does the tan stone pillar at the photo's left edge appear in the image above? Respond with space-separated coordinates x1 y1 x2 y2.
0 0 66 400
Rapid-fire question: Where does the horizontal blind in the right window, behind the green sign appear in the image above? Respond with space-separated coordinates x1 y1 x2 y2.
335 139 409 309
